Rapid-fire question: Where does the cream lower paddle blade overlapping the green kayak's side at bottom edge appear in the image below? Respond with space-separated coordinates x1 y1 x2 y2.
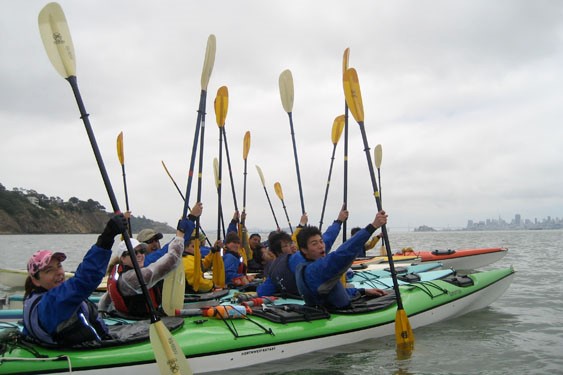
149 320 193 375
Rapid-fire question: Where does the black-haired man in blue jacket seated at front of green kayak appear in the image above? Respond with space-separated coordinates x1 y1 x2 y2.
295 210 387 308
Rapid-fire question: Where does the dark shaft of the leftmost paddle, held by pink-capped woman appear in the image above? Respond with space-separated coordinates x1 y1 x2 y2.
66 76 160 323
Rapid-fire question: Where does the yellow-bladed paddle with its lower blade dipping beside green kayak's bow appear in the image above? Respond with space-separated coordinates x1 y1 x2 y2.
344 68 414 356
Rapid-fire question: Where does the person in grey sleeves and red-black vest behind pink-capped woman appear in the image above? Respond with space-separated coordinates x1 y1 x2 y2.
98 203 203 318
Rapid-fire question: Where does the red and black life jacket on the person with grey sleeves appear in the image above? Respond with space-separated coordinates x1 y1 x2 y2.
107 264 162 317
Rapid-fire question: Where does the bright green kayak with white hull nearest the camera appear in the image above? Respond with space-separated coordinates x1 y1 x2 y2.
0 268 514 375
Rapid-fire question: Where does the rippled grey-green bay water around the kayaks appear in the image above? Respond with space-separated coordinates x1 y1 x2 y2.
0 230 563 375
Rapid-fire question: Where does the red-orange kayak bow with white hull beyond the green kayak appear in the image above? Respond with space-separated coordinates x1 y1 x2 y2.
400 247 508 270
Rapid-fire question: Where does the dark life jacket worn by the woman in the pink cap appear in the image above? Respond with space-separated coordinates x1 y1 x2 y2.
23 292 108 346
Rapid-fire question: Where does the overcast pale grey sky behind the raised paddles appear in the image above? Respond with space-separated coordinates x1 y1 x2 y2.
0 0 563 235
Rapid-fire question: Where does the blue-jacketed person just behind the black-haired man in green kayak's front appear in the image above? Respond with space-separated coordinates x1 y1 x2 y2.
256 206 349 298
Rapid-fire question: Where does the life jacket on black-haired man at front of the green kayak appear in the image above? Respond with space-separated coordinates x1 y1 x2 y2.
295 262 350 308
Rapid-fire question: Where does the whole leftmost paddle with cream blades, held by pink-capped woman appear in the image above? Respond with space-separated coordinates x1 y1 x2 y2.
38 3 192 374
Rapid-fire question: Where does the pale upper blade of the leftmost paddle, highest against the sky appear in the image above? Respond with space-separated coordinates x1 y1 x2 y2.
38 3 76 78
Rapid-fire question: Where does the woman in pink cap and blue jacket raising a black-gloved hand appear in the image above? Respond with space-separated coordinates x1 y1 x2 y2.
23 214 127 346
